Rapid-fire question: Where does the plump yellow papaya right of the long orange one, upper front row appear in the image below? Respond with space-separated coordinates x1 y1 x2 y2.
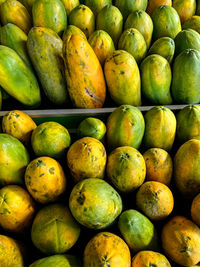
104 50 141 106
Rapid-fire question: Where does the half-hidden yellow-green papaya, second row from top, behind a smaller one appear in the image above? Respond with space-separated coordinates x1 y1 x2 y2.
124 10 153 49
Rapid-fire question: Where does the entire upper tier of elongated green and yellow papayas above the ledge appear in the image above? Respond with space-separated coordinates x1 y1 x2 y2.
0 0 200 108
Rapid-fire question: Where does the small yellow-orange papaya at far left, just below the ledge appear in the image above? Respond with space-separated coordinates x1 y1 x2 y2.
2 110 37 144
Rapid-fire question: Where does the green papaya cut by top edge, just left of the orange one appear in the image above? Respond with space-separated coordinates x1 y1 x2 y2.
115 0 148 21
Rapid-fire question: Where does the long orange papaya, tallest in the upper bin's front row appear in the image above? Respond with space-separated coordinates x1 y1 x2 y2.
63 34 106 108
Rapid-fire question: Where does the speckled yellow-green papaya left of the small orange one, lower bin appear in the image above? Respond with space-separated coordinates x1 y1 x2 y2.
106 146 146 193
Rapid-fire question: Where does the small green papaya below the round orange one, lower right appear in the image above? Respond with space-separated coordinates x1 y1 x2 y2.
118 209 158 253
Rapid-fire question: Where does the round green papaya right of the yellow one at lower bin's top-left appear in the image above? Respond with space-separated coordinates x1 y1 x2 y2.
31 121 71 159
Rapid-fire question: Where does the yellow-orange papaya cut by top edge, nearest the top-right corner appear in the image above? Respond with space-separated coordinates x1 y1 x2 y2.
172 0 196 24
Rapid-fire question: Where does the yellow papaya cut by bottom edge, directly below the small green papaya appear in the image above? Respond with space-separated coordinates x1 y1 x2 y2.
131 250 171 267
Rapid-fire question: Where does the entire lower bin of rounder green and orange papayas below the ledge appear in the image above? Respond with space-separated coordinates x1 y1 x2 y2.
0 105 200 267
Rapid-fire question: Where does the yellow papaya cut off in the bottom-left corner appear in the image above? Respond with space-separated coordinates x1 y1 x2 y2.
0 235 25 267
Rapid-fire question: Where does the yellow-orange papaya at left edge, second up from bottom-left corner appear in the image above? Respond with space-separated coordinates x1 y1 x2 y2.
0 185 35 233
